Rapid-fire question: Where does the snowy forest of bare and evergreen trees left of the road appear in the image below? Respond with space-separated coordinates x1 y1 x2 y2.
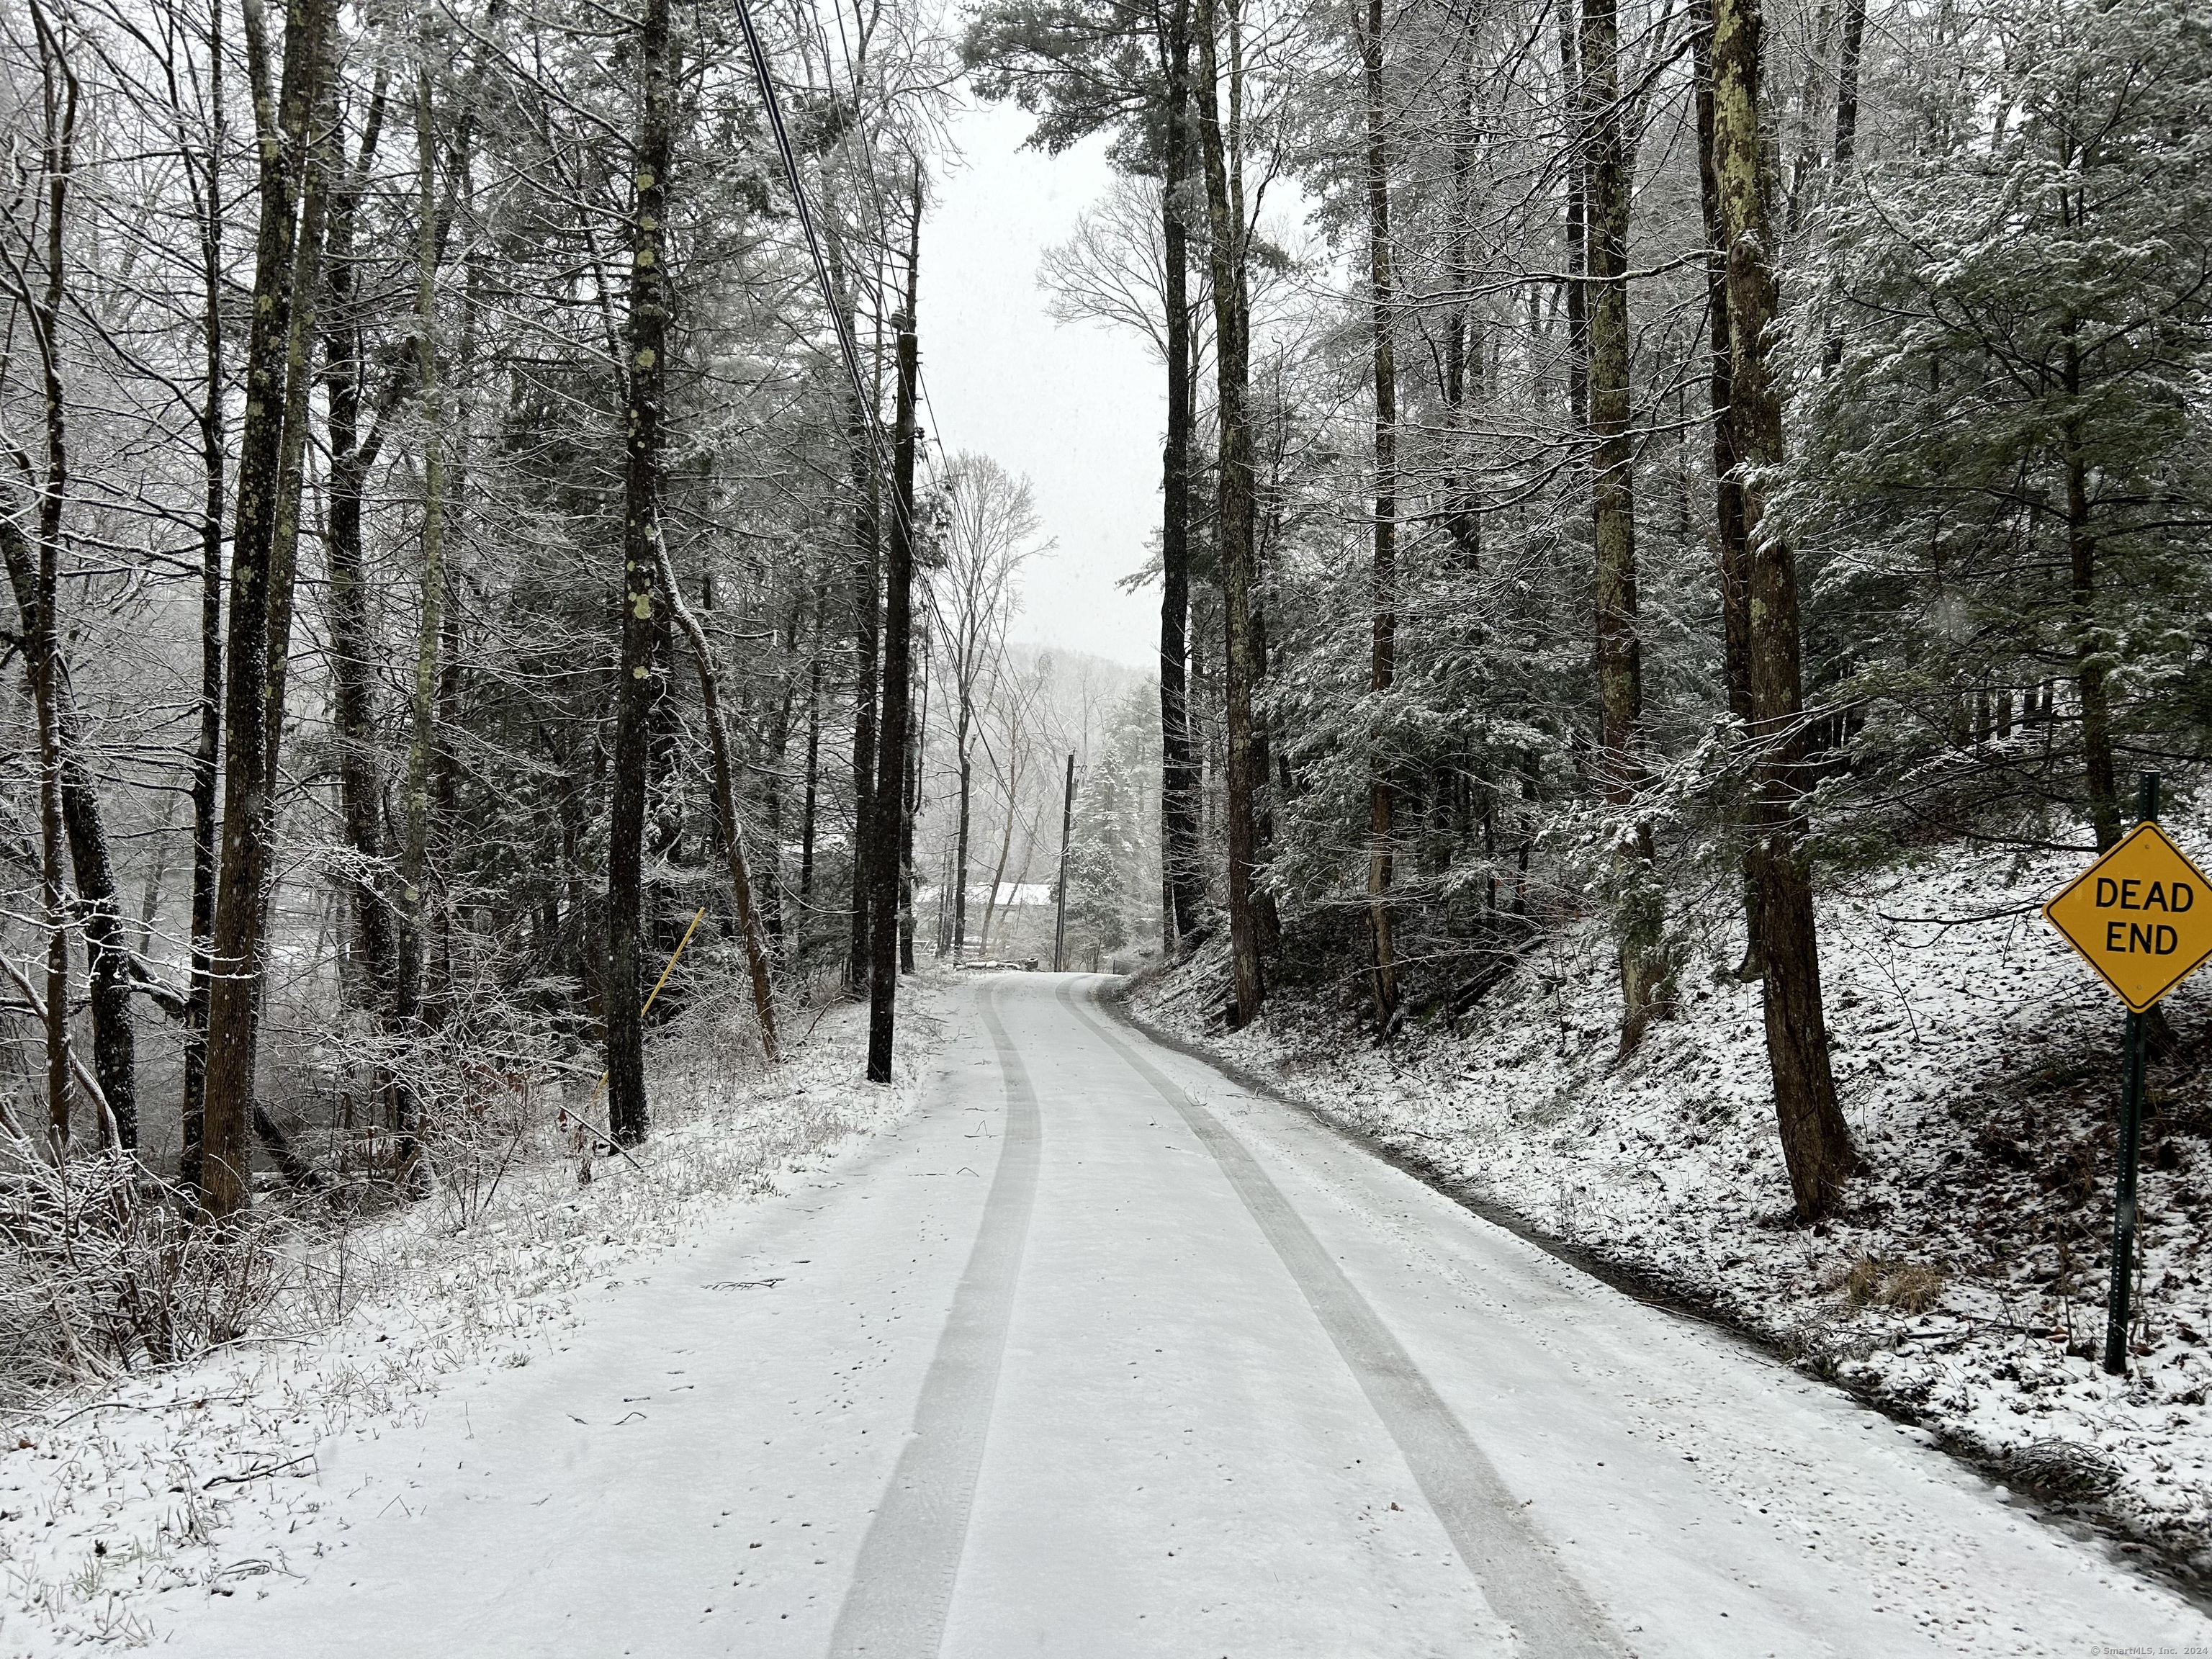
0 0 977 1217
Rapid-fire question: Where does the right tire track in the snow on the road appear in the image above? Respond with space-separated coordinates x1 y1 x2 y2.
1059 984 1626 1659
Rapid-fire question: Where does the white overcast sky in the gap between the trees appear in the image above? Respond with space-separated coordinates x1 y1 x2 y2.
920 104 1166 668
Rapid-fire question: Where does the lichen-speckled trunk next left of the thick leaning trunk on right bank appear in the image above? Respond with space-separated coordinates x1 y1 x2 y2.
1581 0 1665 1055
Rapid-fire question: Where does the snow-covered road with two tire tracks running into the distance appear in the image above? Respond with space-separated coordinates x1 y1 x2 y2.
163 976 2212 1659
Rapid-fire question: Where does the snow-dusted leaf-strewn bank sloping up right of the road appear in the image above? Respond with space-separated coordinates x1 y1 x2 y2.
1133 845 2212 1581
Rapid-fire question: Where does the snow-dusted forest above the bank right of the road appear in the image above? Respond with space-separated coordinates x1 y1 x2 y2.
962 0 2212 1219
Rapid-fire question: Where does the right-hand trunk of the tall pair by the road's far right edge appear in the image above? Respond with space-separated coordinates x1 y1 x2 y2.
1197 0 1265 1026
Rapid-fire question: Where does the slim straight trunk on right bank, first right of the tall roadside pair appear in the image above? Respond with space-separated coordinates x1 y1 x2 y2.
1360 0 1398 1035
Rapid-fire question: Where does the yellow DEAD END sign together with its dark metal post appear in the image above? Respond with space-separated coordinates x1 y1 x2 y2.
2044 772 2212 1376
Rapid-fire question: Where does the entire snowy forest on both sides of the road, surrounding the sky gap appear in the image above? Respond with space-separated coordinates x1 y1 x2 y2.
0 0 2212 1219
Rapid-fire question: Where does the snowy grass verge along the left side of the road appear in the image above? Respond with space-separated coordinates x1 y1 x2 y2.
0 980 945 1659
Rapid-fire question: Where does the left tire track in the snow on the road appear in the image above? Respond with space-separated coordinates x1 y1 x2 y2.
830 991 1040 1659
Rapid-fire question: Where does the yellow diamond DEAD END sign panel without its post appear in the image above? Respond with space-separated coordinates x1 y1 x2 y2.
2044 823 2212 1013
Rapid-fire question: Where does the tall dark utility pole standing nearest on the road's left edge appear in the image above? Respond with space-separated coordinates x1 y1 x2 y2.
867 176 922 1084
